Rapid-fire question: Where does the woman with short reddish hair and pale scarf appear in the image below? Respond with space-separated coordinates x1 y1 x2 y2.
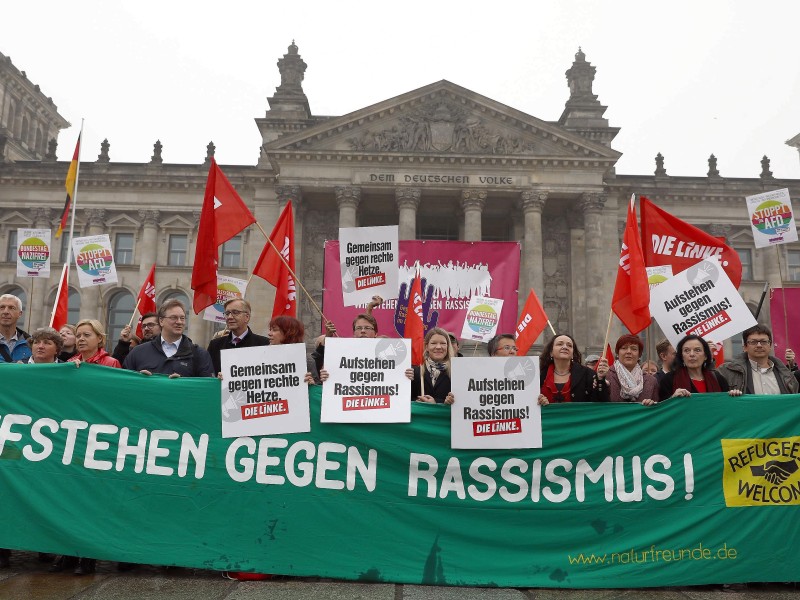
606 334 658 406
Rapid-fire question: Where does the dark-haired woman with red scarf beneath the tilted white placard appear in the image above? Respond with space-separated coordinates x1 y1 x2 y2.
658 333 742 400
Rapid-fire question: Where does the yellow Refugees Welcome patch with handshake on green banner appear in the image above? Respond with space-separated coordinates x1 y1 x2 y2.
722 437 800 506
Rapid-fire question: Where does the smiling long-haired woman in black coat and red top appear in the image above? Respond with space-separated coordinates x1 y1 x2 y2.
539 333 609 406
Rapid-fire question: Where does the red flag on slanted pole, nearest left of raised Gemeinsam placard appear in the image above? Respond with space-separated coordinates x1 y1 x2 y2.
253 200 297 318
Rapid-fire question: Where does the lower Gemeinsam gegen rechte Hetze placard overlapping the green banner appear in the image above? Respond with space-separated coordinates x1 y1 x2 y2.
220 344 311 438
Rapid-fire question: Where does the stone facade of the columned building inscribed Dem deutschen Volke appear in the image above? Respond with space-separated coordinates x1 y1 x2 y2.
0 43 800 350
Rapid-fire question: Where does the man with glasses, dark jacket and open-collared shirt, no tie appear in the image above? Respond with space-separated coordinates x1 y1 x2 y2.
123 299 215 377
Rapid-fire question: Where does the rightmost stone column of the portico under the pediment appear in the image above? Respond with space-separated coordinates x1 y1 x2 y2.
578 192 613 349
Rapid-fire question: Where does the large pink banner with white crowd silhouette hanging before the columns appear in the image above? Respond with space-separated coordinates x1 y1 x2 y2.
322 240 520 337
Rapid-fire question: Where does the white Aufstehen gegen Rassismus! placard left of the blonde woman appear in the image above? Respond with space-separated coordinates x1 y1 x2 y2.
320 338 411 423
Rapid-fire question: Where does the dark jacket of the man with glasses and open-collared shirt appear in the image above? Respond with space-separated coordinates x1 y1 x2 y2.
123 335 217 377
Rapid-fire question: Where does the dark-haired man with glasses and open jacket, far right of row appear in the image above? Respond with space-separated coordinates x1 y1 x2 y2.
719 325 798 395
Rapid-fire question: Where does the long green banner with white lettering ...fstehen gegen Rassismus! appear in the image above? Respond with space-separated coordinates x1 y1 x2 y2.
0 364 800 587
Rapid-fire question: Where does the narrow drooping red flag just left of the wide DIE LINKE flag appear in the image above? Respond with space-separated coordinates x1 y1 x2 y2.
611 196 650 334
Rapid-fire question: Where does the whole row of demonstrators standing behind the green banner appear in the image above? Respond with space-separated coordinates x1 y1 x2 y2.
0 294 800 575
